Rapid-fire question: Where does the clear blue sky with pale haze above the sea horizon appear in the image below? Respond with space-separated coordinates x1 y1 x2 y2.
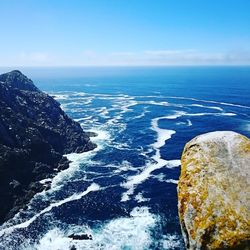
0 0 250 66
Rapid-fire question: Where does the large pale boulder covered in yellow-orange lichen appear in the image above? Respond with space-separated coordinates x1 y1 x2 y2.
178 131 250 249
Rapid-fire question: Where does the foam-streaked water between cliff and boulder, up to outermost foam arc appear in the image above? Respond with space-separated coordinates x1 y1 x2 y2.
0 92 249 250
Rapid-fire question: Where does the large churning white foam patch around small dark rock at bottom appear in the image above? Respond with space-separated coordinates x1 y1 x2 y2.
33 207 158 250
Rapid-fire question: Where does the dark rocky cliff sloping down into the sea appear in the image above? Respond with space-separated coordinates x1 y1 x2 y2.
0 70 95 223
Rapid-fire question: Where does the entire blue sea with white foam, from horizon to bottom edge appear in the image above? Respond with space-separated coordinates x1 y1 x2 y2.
0 67 250 250
